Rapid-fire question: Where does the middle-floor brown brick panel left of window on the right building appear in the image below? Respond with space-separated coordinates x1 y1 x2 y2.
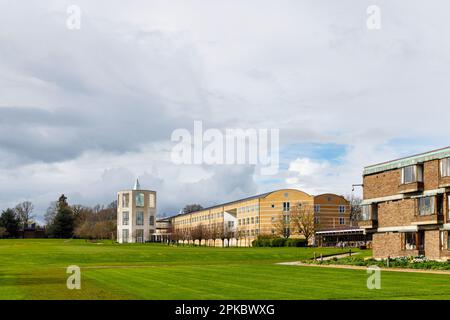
378 199 416 228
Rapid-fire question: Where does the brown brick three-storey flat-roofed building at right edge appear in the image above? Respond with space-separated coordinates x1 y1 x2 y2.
359 147 450 260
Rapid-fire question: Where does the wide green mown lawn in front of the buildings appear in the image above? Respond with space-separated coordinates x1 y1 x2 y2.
0 239 450 300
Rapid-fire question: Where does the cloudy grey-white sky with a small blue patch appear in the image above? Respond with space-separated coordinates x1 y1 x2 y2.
0 0 450 219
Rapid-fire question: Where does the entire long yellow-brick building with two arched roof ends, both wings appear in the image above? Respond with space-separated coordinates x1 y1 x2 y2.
171 189 363 246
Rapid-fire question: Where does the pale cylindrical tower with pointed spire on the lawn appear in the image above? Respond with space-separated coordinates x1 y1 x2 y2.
117 179 156 243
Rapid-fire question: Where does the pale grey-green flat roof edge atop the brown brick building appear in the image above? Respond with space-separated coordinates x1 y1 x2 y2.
363 146 450 175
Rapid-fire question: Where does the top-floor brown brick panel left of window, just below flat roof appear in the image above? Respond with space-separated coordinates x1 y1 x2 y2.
363 169 401 199
